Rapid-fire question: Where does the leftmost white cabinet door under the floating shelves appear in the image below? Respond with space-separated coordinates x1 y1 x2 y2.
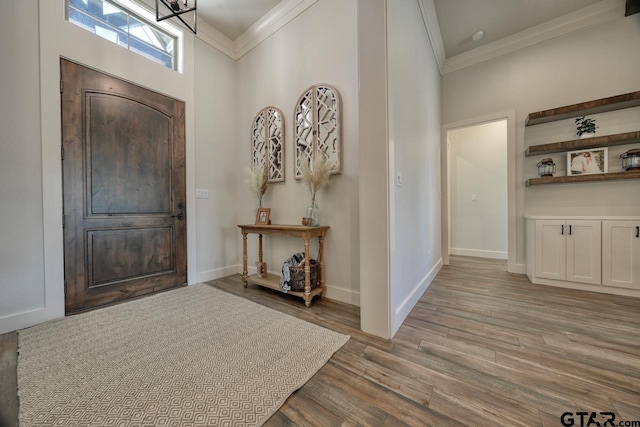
535 219 566 280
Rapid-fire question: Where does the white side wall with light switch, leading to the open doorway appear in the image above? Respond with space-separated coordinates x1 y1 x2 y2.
387 1 442 336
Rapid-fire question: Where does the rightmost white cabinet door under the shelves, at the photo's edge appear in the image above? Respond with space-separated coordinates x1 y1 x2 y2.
602 221 640 289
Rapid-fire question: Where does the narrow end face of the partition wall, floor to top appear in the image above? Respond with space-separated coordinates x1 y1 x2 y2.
358 0 391 338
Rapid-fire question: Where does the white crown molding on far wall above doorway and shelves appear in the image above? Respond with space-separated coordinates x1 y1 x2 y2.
440 0 625 74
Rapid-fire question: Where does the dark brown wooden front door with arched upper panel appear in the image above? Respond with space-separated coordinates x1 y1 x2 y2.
61 59 187 313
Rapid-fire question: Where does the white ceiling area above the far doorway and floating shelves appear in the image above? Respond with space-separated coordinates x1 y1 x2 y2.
434 0 600 58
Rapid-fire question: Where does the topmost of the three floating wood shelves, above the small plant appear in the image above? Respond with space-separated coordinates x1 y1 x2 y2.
525 91 640 126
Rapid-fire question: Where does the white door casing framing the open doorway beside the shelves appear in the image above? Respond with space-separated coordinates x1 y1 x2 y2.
440 110 526 274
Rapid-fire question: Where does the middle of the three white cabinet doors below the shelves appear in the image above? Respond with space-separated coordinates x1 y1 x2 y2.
565 220 602 285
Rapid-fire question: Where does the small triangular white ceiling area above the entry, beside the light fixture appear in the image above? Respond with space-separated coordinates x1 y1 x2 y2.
198 0 281 40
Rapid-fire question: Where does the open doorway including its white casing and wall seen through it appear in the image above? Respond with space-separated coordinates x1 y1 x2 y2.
442 110 526 274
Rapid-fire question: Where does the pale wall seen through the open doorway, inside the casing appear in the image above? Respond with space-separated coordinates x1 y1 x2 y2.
443 120 507 259
